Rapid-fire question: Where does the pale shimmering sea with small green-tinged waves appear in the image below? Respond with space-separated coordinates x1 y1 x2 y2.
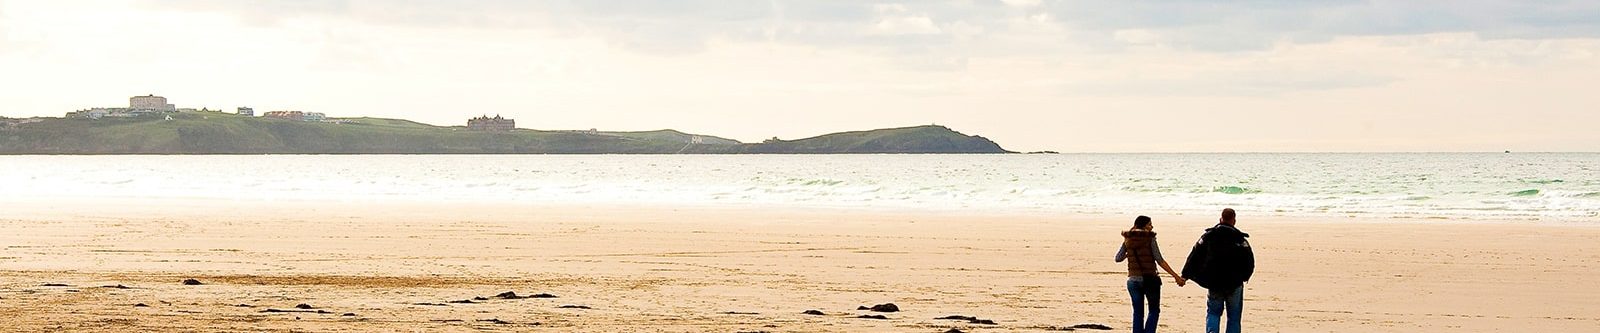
0 154 1600 223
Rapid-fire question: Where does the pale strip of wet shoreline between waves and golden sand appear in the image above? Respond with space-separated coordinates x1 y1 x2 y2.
0 197 1600 229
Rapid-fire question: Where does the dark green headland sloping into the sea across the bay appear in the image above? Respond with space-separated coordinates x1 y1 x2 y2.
0 112 1006 154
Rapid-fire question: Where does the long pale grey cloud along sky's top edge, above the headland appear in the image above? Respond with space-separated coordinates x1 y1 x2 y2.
142 0 1002 54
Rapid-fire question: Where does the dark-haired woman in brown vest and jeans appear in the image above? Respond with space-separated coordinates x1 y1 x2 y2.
1117 216 1184 333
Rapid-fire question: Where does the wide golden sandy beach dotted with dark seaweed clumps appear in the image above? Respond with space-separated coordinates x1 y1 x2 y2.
0 203 1600 331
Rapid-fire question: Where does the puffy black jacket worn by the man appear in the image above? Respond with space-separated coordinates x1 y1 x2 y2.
1182 224 1256 290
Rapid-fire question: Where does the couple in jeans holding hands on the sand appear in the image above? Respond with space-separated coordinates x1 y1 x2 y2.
1117 208 1256 333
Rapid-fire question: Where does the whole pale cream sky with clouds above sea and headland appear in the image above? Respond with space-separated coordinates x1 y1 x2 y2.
0 0 1600 152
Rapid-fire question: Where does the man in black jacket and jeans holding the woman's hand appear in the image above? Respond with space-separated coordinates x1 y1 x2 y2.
1184 208 1256 333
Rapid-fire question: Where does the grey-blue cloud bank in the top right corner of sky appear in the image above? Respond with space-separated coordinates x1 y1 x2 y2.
1042 0 1600 51
